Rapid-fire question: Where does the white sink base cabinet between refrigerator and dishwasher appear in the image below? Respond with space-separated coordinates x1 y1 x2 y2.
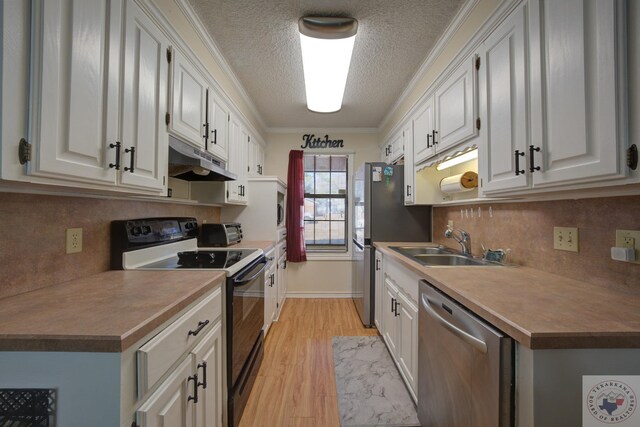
376 259 420 400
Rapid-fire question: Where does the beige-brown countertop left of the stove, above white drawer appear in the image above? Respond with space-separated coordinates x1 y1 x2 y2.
0 270 225 352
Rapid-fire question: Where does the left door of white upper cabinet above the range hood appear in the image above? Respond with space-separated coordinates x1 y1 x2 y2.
169 49 208 149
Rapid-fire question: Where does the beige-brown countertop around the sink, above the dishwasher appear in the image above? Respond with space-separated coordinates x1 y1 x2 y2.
375 242 640 349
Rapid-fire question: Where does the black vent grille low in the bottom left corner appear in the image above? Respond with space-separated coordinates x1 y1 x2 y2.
0 388 56 427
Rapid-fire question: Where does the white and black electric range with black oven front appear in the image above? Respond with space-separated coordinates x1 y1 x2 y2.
111 218 268 427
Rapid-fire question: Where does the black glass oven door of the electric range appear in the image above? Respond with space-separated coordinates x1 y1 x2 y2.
226 256 267 388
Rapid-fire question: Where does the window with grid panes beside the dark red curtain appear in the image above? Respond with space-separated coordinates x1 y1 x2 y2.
304 155 349 252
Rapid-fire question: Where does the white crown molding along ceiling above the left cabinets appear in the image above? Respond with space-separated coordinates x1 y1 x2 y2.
176 0 267 133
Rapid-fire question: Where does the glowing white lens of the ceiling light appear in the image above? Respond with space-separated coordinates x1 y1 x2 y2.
300 18 356 113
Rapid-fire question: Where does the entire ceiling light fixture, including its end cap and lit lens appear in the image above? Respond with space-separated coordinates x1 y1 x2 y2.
298 16 358 113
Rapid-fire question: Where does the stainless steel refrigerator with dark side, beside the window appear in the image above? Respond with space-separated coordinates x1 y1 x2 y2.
352 163 431 326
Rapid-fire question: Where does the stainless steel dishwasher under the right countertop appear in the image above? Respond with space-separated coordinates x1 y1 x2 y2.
418 280 515 427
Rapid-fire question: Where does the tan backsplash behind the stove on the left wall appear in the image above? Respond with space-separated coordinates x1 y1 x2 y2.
0 193 220 298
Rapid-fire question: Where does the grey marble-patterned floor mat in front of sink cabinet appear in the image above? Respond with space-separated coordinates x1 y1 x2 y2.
333 336 420 427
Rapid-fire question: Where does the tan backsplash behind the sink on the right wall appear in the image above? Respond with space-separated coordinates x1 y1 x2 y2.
433 196 640 294
